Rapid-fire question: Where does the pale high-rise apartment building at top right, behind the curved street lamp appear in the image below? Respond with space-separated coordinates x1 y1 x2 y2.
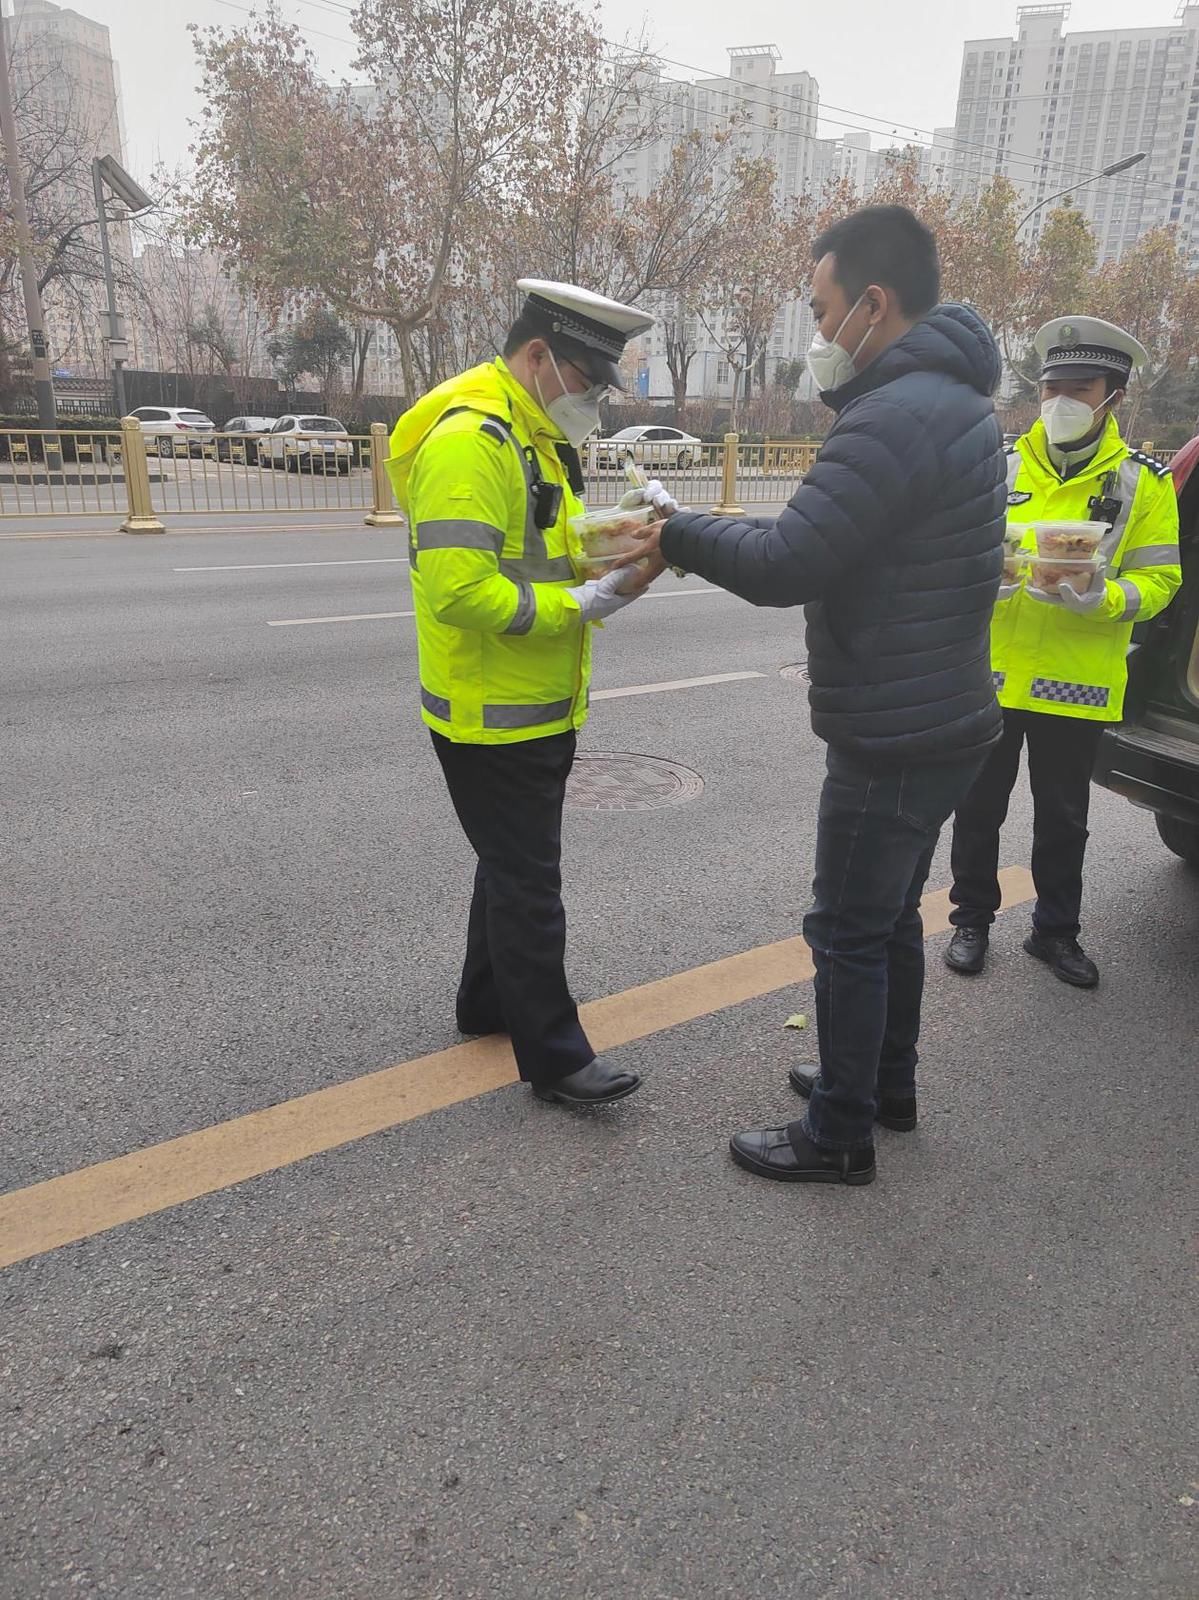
944 0 1199 261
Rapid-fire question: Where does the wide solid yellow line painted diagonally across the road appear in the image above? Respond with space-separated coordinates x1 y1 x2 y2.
0 867 1033 1267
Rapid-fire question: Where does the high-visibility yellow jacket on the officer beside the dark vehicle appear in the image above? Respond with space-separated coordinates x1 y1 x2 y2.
991 416 1181 722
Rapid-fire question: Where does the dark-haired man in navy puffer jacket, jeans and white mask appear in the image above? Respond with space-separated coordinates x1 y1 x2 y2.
621 206 1005 1184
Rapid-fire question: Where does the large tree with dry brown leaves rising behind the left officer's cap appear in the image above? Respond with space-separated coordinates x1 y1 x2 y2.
189 0 597 395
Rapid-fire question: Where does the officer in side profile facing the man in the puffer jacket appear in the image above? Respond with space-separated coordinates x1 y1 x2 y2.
387 278 653 1104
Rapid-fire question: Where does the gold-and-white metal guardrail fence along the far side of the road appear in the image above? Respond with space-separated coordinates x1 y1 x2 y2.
0 418 1177 533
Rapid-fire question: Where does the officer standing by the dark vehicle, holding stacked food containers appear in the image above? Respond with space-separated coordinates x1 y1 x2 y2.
946 317 1181 989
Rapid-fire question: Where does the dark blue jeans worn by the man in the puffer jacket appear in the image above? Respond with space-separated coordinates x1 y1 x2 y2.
804 746 983 1150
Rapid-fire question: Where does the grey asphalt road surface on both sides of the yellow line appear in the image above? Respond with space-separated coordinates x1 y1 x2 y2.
0 518 1199 1600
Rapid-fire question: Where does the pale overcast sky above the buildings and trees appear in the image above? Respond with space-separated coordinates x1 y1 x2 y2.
49 0 1177 179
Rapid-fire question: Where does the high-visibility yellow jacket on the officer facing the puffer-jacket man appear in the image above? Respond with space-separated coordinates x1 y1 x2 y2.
387 360 591 744
